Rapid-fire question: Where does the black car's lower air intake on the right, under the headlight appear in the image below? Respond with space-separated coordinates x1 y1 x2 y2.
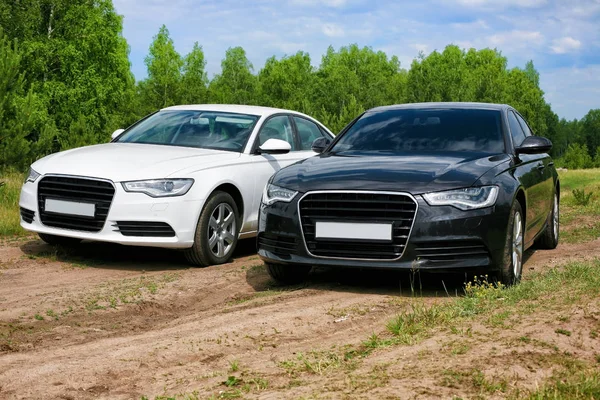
415 240 490 263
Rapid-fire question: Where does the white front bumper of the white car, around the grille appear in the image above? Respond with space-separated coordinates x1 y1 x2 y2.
19 178 204 248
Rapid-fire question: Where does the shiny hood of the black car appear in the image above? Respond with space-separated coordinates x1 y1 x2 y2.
273 152 509 194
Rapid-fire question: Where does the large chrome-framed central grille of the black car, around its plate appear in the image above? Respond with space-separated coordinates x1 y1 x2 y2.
299 192 417 260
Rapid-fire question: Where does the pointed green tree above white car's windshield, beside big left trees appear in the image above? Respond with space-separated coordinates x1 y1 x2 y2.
138 25 183 114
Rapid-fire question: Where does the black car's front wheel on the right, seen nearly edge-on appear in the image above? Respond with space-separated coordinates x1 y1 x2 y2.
498 201 525 286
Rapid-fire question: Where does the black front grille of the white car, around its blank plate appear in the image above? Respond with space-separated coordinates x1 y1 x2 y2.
38 176 115 232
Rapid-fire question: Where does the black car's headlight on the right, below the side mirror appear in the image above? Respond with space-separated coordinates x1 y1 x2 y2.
423 186 498 210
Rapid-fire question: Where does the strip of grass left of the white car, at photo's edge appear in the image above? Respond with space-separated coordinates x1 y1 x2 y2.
0 172 26 236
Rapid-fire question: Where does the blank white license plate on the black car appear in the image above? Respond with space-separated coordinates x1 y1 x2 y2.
315 221 392 242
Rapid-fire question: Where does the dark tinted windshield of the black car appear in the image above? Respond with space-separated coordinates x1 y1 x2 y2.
330 108 504 154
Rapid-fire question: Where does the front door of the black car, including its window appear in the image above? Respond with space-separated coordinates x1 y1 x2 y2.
508 110 544 245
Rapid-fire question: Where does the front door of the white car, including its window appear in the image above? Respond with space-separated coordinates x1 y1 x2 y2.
248 114 315 230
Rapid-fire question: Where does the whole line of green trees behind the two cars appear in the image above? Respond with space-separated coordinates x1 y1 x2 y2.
0 0 600 168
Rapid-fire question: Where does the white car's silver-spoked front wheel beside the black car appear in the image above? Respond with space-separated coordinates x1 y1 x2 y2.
184 192 240 267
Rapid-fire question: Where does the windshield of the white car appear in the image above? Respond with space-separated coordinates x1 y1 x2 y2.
116 110 259 152
